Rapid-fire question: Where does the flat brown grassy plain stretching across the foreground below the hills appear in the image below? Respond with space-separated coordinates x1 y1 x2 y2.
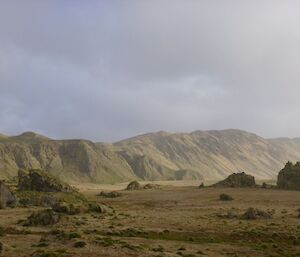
0 186 300 257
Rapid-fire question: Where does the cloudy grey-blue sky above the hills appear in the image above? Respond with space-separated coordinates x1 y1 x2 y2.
0 0 300 142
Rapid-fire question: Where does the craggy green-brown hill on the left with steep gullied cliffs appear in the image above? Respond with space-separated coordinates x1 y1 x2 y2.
0 132 135 183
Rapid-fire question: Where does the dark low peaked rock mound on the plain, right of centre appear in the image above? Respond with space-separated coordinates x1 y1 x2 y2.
213 172 256 188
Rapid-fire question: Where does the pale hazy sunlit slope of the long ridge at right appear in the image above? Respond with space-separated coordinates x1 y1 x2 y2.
115 130 300 180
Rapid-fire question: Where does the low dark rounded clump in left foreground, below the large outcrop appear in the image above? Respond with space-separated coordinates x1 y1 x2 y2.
24 209 60 226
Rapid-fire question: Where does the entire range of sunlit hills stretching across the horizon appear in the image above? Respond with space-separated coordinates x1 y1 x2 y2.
0 130 300 183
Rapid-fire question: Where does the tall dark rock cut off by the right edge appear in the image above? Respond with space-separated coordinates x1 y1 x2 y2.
277 162 300 190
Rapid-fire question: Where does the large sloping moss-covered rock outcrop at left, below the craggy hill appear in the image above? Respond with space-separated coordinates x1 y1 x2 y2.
18 169 73 192
